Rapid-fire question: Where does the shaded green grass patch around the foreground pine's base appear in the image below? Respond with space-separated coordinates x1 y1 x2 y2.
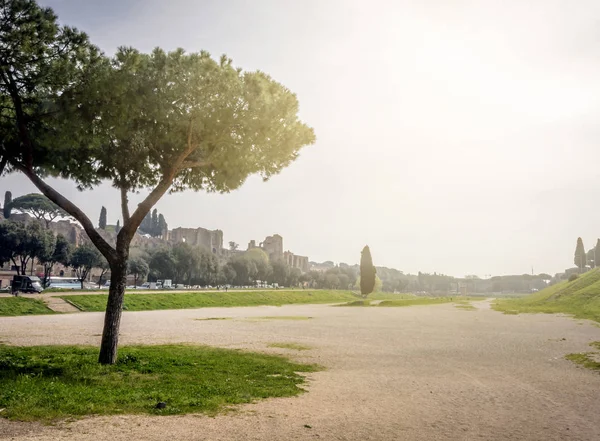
0 345 319 421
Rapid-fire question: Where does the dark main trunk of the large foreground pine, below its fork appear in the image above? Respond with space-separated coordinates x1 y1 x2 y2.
98 244 129 364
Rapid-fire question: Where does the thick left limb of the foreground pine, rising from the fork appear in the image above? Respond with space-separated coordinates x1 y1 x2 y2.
11 163 117 262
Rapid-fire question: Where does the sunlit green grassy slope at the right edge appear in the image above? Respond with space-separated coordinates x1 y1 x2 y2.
493 269 600 322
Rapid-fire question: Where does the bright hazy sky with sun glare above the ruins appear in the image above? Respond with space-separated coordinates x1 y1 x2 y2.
0 0 600 277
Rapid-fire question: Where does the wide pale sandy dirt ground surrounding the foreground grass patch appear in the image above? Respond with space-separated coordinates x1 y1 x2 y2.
0 302 600 441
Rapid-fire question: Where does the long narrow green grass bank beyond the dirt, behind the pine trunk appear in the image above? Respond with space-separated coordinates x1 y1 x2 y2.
61 290 355 311
